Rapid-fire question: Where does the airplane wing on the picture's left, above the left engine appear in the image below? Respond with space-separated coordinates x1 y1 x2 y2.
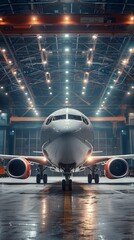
0 154 50 166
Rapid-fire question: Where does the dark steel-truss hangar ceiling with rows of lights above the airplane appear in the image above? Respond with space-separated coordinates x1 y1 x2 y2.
0 0 134 116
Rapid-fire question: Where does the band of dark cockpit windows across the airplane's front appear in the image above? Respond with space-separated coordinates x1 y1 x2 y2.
46 114 89 125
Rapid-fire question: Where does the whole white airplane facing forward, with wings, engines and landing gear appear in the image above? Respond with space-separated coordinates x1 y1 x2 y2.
0 108 134 190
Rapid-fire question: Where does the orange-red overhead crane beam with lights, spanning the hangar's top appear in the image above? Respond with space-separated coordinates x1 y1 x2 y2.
0 14 134 35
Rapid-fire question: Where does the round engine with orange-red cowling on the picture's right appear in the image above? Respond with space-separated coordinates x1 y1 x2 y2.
104 158 129 179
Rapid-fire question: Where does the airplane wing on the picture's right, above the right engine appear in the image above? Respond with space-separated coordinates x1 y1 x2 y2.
84 154 134 167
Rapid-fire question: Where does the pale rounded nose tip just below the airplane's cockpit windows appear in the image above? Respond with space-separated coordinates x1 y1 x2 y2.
53 120 82 133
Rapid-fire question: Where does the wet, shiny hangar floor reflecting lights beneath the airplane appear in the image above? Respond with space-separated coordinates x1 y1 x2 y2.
0 177 134 240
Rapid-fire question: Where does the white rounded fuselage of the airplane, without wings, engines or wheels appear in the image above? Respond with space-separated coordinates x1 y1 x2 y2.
41 108 94 171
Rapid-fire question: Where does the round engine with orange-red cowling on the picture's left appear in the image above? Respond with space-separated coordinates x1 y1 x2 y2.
7 158 31 179
